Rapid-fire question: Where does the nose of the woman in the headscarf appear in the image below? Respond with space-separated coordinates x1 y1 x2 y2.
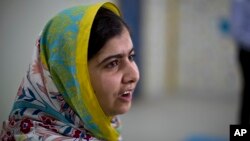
122 62 140 84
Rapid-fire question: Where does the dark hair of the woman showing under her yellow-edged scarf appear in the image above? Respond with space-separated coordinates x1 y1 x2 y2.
88 7 129 60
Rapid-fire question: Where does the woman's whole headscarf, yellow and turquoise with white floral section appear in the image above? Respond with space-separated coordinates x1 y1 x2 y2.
1 2 121 141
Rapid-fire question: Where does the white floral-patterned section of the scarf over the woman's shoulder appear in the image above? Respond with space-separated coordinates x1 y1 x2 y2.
0 1 121 141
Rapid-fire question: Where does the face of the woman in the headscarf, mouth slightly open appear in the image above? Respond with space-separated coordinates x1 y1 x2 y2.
88 29 139 116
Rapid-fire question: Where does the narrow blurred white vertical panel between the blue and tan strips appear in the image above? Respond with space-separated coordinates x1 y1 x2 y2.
141 0 167 98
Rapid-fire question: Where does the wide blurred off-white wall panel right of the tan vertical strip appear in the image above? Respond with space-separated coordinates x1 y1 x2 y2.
179 0 239 95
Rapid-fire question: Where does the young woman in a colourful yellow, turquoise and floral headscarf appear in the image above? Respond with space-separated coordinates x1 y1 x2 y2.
0 2 139 141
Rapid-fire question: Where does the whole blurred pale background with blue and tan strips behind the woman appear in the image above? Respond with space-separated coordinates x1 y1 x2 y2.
0 0 241 141
